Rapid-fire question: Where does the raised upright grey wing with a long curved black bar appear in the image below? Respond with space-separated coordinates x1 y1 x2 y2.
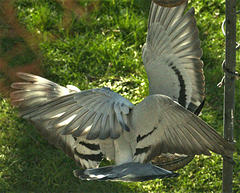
142 3 205 113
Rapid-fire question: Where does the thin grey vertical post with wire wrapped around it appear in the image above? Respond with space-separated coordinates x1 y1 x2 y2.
222 0 236 193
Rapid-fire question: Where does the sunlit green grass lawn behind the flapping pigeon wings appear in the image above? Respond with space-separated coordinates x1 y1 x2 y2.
0 0 240 192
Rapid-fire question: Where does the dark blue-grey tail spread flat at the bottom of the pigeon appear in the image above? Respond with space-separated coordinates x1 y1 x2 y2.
74 162 179 182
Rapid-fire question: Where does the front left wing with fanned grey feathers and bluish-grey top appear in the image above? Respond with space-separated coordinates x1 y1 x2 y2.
16 88 133 140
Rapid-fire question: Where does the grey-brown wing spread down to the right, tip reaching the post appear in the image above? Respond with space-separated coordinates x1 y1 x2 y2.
131 95 234 163
